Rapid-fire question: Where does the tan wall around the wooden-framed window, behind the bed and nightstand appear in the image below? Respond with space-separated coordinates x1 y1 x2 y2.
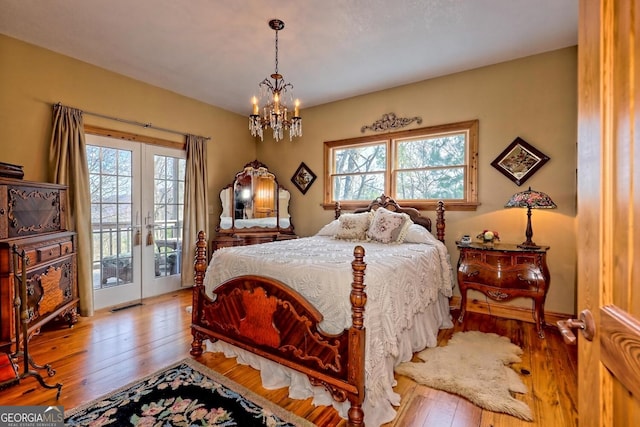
257 47 577 314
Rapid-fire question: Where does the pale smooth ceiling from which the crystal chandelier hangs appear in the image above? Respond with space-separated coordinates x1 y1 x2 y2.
0 0 578 114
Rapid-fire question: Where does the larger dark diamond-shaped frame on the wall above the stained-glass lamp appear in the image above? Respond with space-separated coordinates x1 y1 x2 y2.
491 137 549 186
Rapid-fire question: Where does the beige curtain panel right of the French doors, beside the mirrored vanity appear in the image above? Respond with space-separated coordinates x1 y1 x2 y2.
181 135 209 287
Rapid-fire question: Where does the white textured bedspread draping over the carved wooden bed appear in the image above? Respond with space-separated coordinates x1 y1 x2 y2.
205 236 453 426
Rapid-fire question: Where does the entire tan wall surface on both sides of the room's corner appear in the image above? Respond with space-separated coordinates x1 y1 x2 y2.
0 35 577 313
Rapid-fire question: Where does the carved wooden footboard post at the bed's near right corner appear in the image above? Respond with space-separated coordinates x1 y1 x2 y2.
347 246 367 427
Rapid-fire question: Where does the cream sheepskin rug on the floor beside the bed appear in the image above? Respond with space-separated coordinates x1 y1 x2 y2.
395 331 533 421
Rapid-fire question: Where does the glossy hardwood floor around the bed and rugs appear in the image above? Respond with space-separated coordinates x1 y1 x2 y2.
0 290 578 427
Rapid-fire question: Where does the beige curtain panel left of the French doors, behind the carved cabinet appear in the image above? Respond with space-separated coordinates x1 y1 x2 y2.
49 104 93 316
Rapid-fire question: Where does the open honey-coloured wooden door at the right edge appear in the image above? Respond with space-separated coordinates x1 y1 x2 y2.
577 0 640 427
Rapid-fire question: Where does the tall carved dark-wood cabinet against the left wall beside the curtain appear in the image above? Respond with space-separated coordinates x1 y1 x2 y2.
0 178 78 352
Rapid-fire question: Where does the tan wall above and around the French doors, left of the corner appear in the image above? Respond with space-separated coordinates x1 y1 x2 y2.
0 35 256 235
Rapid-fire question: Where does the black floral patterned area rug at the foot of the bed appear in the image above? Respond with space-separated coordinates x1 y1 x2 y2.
65 359 313 427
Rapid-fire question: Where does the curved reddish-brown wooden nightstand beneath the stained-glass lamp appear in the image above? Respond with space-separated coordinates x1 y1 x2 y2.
456 242 551 338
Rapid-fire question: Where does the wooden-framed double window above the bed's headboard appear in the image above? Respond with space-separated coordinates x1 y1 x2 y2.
324 120 478 210
